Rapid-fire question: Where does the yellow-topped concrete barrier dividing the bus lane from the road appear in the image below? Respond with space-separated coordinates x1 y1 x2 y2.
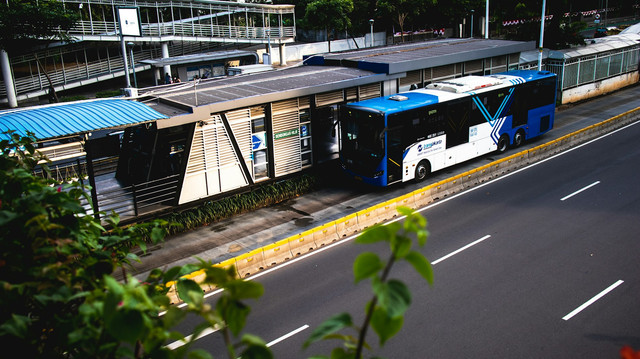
166 107 640 303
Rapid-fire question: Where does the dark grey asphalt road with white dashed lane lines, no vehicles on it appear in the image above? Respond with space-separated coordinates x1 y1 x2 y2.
171 110 640 358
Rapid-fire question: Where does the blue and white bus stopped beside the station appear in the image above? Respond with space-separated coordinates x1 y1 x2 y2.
340 70 556 186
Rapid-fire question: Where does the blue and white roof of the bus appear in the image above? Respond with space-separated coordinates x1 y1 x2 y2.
347 70 555 114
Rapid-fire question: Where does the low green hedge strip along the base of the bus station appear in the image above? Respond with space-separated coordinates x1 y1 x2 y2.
162 174 318 235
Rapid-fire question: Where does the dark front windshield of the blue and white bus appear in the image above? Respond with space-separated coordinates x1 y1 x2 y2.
340 107 384 176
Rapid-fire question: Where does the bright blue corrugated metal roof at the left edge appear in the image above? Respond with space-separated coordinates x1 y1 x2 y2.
0 99 167 140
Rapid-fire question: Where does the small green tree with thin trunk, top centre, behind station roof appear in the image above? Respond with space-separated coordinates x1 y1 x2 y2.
302 0 353 52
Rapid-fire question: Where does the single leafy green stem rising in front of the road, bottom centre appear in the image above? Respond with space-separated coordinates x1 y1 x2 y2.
304 207 433 359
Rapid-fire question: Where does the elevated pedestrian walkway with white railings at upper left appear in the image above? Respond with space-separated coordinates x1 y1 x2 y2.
0 0 296 104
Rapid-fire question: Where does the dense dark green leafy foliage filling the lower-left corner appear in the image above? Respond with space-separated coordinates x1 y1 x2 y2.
0 134 270 358
